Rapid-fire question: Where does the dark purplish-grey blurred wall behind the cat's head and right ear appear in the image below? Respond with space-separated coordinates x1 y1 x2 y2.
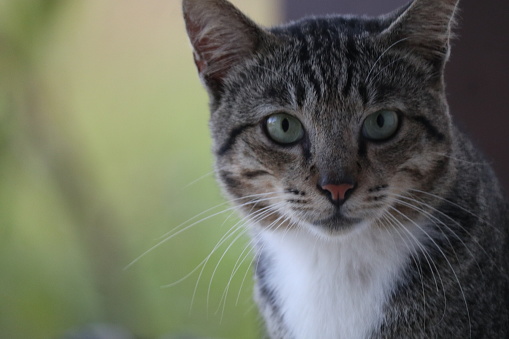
282 0 509 194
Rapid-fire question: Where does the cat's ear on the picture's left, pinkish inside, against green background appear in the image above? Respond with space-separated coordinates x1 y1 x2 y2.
182 0 266 100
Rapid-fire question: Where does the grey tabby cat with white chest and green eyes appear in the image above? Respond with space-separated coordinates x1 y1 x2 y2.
183 0 509 339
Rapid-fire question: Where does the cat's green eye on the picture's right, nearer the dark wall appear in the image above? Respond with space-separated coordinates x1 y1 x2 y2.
362 110 398 141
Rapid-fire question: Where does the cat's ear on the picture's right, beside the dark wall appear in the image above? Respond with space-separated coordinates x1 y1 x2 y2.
382 0 459 69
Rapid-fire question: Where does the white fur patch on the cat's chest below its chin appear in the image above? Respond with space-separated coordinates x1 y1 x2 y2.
261 225 419 339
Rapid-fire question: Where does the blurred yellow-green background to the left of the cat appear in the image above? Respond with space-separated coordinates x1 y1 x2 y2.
0 0 278 339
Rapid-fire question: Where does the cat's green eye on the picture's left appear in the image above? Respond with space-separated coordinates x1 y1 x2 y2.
265 113 304 144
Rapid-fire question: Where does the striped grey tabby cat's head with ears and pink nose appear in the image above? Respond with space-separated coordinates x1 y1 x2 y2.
183 0 457 238
